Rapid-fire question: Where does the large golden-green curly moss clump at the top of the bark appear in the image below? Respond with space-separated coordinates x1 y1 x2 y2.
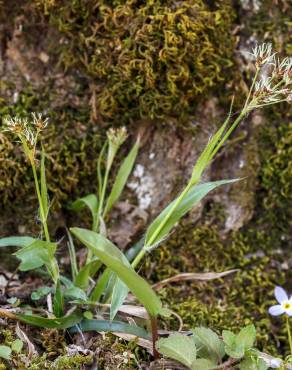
35 0 234 124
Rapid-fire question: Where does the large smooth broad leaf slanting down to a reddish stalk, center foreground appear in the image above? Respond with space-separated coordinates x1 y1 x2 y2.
71 228 163 316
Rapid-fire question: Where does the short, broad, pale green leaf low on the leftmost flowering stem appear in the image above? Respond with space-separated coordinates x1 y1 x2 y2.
14 239 57 271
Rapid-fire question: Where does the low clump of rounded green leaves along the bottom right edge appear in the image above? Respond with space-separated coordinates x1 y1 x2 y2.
157 325 268 370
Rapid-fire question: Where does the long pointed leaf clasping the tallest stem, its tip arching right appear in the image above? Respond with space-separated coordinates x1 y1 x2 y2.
145 179 239 246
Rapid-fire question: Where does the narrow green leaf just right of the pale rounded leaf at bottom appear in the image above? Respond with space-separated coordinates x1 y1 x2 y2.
193 327 225 361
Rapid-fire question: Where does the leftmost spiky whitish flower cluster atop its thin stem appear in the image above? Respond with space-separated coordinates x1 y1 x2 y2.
3 113 49 147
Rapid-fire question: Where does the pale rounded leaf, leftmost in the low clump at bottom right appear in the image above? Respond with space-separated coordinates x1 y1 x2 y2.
156 333 197 368
